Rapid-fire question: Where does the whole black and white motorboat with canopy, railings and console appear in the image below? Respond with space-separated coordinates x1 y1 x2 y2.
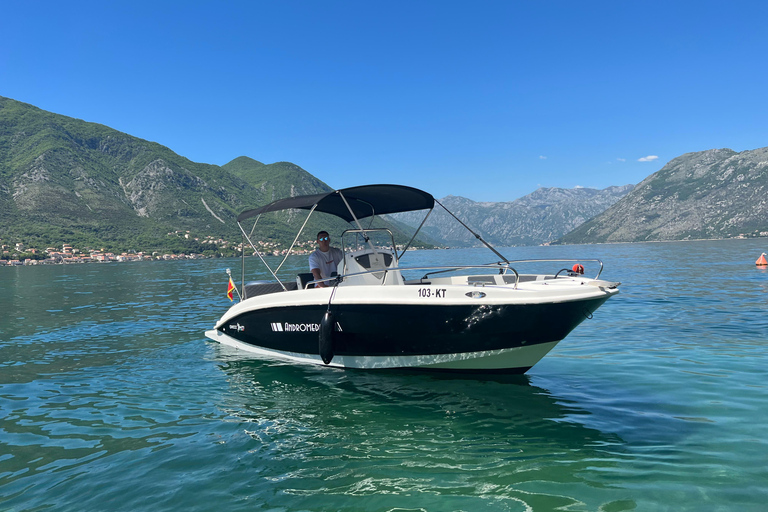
206 184 620 373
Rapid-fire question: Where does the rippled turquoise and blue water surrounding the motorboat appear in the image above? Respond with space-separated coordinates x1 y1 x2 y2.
0 240 768 512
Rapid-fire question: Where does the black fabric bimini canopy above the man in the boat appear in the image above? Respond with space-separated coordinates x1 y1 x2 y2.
237 185 435 222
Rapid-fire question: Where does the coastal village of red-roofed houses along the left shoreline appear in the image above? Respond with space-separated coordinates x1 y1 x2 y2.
0 231 316 267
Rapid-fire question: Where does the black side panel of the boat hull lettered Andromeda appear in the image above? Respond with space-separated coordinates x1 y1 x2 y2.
219 296 608 358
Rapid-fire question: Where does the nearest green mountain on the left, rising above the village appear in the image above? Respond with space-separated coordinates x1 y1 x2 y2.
0 97 256 252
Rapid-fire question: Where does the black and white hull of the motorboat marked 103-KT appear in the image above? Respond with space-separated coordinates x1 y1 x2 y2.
206 278 618 373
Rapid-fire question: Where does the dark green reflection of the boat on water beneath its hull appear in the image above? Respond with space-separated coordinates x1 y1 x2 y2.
217 347 624 452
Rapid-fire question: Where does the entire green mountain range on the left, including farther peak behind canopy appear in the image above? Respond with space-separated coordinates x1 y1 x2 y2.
0 97 426 252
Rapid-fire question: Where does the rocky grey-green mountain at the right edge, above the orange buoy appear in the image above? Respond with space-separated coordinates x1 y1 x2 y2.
560 148 768 243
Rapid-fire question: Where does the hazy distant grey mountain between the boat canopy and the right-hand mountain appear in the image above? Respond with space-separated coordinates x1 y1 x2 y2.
394 185 633 247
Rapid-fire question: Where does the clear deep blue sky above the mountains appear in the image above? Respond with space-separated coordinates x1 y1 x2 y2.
0 0 768 201
